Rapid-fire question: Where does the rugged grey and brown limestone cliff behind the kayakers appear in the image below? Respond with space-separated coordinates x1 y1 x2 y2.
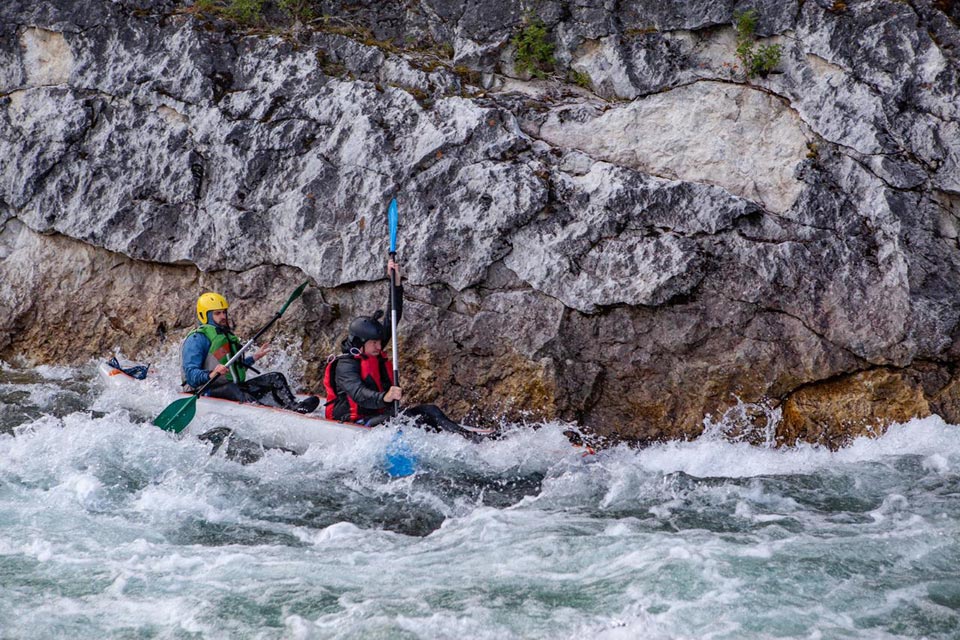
0 0 960 446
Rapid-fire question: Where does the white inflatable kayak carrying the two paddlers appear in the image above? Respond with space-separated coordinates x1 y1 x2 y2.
99 362 493 453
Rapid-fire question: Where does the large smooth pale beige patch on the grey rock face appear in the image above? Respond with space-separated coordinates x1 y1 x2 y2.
538 82 813 213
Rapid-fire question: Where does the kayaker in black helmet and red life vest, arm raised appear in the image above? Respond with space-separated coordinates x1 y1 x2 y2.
323 260 475 437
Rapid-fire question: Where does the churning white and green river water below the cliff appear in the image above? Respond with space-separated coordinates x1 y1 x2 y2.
0 364 960 639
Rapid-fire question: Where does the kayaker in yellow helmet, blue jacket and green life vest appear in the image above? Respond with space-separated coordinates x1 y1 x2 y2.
180 291 320 413
